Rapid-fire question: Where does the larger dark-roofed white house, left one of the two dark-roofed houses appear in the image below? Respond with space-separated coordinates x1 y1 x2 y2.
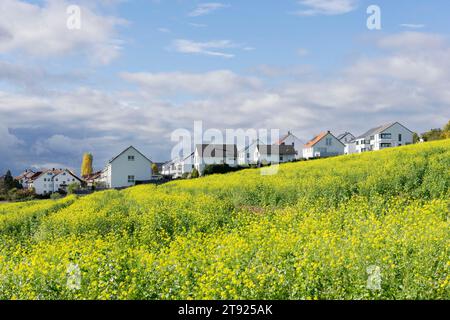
194 144 238 174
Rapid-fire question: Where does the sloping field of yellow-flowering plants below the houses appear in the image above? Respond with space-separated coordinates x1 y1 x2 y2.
0 140 450 299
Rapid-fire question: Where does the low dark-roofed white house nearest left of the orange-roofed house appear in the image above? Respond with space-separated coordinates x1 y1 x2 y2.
253 144 297 164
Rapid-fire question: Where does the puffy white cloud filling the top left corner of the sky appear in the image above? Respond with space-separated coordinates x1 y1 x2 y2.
0 0 125 64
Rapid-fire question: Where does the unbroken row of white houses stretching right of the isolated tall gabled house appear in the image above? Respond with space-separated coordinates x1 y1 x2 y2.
162 122 413 178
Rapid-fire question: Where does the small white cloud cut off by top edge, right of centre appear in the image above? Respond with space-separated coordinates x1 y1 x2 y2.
296 0 358 16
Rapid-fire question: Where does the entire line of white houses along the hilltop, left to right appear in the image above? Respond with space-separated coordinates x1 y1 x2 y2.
16 122 413 194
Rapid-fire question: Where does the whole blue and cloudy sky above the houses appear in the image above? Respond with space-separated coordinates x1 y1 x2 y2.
0 0 450 173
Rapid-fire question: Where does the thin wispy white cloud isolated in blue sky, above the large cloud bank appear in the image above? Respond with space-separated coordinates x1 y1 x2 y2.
172 39 238 59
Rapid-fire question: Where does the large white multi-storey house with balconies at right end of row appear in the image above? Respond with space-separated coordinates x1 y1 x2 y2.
345 122 414 154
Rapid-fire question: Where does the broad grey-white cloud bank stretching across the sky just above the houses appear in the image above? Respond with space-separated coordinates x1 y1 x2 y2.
0 33 450 174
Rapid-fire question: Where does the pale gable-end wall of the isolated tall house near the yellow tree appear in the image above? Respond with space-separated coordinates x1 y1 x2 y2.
107 148 152 188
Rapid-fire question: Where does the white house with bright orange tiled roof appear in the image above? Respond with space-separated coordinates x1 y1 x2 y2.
303 131 345 159
